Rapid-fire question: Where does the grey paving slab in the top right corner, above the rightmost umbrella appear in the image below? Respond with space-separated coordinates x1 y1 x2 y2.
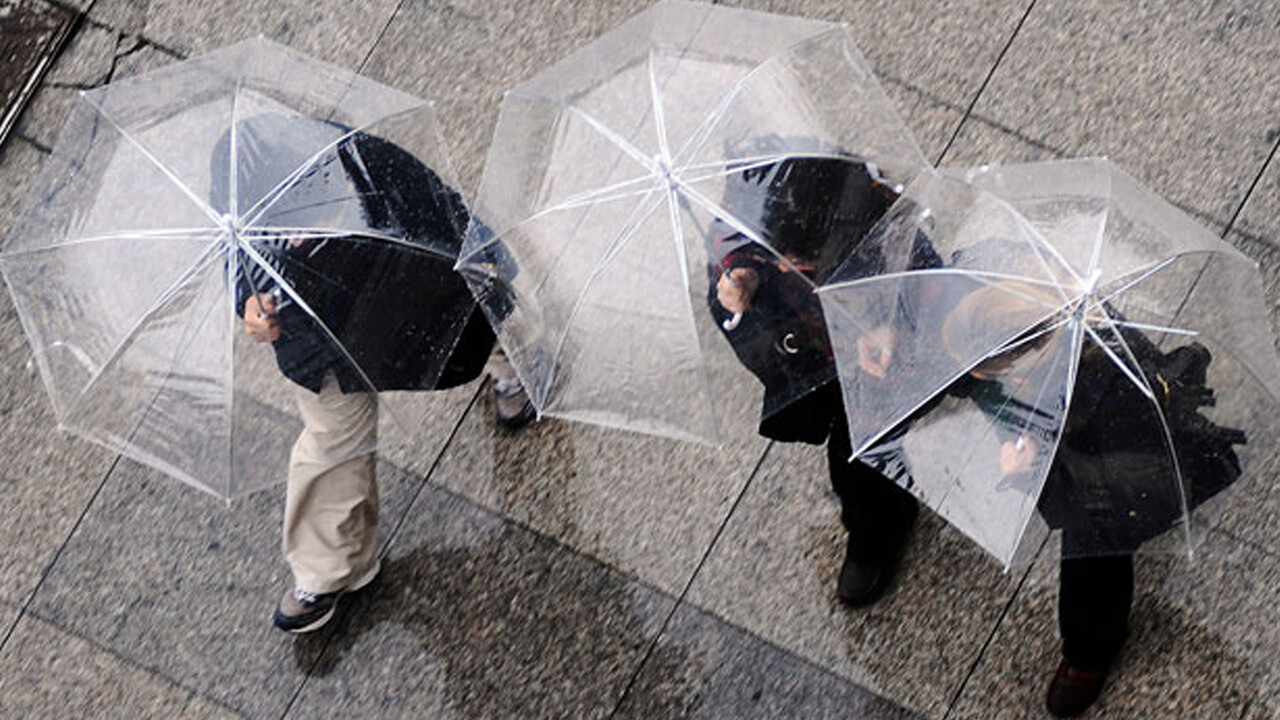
965 0 1280 223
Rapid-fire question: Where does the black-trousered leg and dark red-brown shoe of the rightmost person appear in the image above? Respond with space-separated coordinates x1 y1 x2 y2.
1046 555 1133 717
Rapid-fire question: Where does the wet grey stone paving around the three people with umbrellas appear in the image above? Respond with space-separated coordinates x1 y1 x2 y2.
0 0 1280 720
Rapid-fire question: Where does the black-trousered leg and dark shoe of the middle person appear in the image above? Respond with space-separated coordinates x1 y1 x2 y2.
827 409 919 607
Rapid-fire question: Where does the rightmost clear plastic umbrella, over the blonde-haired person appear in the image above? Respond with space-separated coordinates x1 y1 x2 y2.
819 159 1280 565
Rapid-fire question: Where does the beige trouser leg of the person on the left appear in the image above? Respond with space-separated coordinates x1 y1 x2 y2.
283 373 378 593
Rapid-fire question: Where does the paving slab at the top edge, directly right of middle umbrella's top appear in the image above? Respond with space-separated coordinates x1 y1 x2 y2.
726 0 1028 111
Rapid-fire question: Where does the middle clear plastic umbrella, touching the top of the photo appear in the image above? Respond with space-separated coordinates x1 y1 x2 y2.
460 1 927 443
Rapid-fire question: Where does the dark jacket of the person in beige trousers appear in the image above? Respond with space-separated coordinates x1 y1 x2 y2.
212 117 494 392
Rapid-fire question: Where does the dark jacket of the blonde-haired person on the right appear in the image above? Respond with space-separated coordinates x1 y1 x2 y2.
947 319 1247 555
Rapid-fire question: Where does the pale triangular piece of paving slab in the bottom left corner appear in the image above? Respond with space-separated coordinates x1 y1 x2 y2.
0 607 238 720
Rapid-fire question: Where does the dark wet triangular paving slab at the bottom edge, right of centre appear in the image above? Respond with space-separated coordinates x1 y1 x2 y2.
614 597 920 720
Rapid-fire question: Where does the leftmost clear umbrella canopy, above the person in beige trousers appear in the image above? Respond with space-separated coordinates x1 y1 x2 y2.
0 38 474 498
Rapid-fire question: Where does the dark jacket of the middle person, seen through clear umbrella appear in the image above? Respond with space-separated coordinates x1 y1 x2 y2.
708 158 941 445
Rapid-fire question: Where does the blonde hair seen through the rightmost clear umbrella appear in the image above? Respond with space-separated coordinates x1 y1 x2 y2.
942 281 1065 375
